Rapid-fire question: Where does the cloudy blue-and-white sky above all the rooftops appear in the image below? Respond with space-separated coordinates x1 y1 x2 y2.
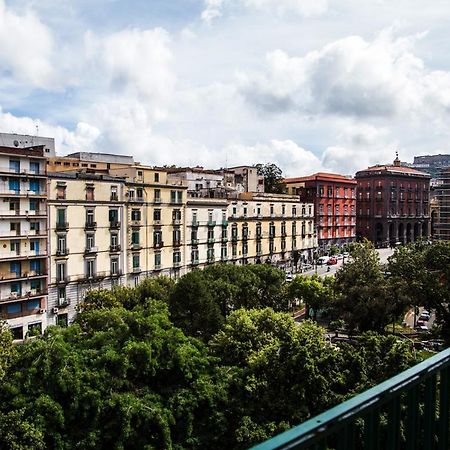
0 0 450 177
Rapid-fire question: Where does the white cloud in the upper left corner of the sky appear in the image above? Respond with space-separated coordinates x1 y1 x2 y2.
0 0 56 90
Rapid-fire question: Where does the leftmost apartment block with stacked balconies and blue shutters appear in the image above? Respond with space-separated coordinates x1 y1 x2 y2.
0 144 51 339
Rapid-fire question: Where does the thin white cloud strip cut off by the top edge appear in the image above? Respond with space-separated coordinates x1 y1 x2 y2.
201 0 329 23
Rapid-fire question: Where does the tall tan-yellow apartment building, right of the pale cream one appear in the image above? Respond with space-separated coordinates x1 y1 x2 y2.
109 164 187 284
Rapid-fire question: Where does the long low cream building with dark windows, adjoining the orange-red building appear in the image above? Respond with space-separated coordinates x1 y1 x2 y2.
228 192 317 270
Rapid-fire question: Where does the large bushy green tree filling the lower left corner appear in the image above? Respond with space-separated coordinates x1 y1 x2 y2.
0 301 227 450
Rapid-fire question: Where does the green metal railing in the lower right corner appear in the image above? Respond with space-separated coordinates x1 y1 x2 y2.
253 349 450 450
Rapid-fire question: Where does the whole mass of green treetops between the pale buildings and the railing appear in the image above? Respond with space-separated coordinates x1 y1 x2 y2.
0 265 414 450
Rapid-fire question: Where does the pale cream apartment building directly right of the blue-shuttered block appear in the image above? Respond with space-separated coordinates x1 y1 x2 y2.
47 172 127 325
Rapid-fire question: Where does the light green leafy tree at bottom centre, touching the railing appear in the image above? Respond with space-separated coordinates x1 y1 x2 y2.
210 308 342 448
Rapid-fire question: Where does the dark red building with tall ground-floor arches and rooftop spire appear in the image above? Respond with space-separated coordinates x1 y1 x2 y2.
355 157 431 246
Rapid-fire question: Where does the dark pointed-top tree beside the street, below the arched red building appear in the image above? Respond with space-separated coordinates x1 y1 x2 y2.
334 240 404 333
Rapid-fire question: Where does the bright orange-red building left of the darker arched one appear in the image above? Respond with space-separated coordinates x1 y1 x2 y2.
284 172 356 250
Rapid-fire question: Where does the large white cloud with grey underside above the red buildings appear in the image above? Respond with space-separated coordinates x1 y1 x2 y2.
240 30 450 117
